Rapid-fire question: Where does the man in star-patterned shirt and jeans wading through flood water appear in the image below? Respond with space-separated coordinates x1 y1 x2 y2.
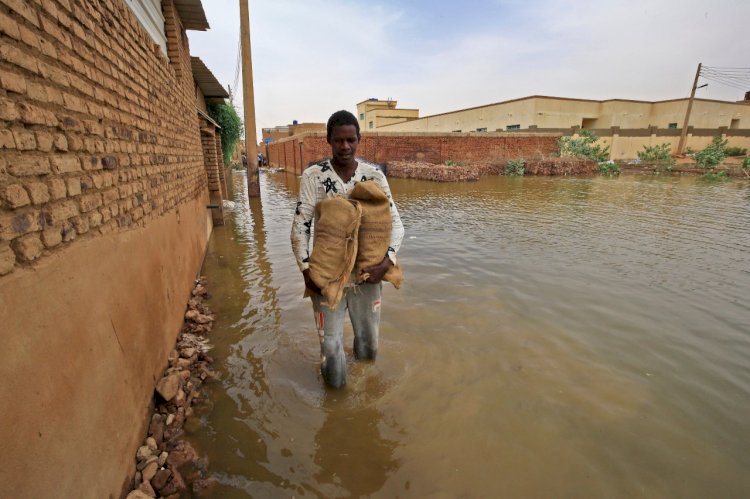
291 111 404 388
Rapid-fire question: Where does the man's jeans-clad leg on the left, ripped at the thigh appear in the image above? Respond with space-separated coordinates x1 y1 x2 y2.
311 295 346 388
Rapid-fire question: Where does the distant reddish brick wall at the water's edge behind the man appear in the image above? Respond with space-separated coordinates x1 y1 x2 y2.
268 133 560 173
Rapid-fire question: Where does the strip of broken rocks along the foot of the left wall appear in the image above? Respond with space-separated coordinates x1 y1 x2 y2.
127 277 216 499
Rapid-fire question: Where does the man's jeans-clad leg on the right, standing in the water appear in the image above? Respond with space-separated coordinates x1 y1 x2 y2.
346 283 383 360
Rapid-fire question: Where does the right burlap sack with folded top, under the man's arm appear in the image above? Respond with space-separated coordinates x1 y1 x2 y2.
349 180 404 289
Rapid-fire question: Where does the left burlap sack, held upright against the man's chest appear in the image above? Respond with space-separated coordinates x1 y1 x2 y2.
309 197 362 308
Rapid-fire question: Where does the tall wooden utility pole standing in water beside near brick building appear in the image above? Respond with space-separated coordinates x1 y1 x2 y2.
240 0 260 197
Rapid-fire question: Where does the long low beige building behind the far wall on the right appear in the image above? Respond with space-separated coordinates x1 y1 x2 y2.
378 95 750 132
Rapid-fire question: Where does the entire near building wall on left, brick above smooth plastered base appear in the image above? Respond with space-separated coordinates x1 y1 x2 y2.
0 0 211 498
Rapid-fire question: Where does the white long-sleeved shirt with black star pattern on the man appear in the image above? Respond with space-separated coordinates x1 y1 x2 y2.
292 159 404 271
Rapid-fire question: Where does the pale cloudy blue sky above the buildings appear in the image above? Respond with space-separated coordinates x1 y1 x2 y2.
188 0 750 143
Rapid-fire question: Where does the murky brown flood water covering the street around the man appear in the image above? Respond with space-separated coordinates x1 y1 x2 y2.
188 173 750 498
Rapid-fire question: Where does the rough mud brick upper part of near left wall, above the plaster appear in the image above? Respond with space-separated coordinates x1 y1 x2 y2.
0 0 206 275
